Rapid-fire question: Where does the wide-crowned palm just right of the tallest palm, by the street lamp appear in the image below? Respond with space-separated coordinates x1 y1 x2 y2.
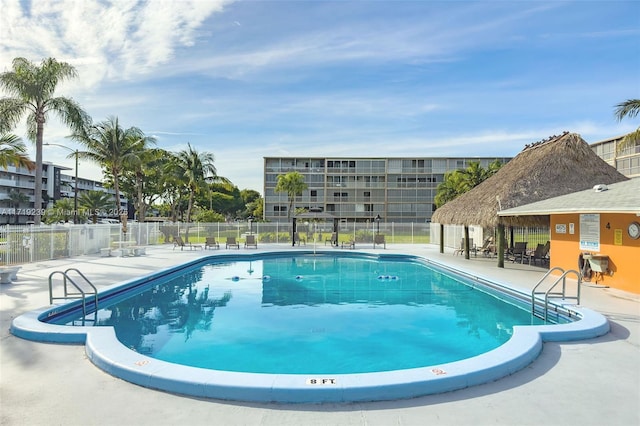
70 117 155 216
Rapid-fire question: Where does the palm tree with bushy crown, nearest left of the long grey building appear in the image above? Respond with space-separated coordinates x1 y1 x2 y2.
175 144 217 222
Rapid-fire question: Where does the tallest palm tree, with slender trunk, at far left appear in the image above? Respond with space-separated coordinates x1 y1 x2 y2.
0 58 90 225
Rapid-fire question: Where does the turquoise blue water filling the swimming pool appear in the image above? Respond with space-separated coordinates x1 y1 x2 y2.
51 254 542 374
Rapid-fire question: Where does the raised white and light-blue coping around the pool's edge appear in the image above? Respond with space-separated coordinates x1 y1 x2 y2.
11 250 609 403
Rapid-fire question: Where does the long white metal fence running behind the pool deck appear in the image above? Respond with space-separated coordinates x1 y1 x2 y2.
0 221 549 265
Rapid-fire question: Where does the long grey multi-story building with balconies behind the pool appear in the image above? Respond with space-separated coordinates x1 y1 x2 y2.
264 157 510 222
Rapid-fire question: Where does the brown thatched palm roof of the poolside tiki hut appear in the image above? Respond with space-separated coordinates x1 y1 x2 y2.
431 132 628 227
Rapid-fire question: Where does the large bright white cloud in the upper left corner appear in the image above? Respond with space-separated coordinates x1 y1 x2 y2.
0 0 231 90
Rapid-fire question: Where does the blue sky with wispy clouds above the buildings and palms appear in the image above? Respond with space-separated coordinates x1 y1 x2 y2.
0 0 640 192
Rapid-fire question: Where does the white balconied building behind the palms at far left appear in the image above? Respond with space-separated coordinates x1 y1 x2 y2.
0 162 127 225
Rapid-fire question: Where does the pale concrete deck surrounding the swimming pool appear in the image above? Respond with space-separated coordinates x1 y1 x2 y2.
0 244 640 426
